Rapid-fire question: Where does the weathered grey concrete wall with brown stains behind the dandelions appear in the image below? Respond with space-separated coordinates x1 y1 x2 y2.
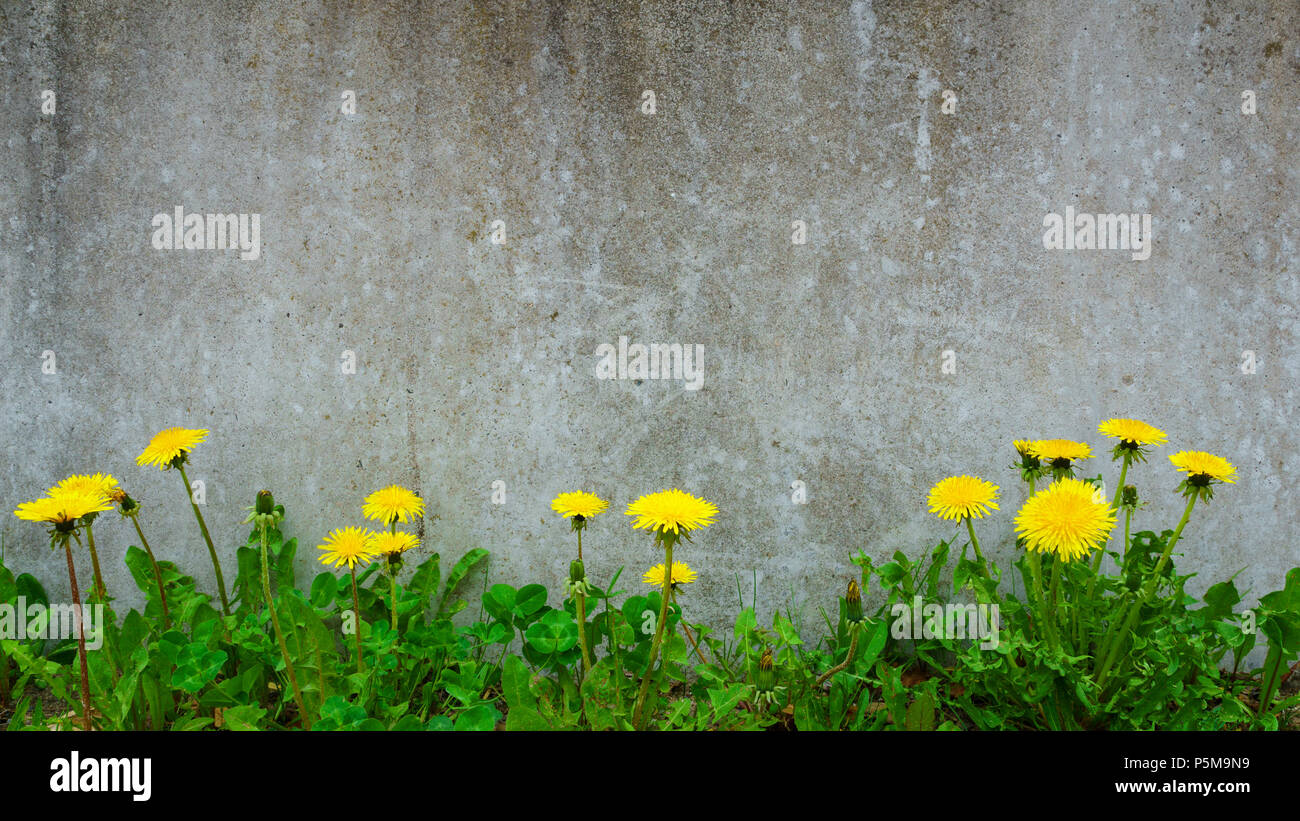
0 0 1300 641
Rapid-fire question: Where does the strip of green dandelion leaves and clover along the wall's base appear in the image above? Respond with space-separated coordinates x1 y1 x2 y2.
0 491 1300 731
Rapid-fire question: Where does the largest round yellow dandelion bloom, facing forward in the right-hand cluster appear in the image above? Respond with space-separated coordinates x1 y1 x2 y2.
1015 478 1115 561
